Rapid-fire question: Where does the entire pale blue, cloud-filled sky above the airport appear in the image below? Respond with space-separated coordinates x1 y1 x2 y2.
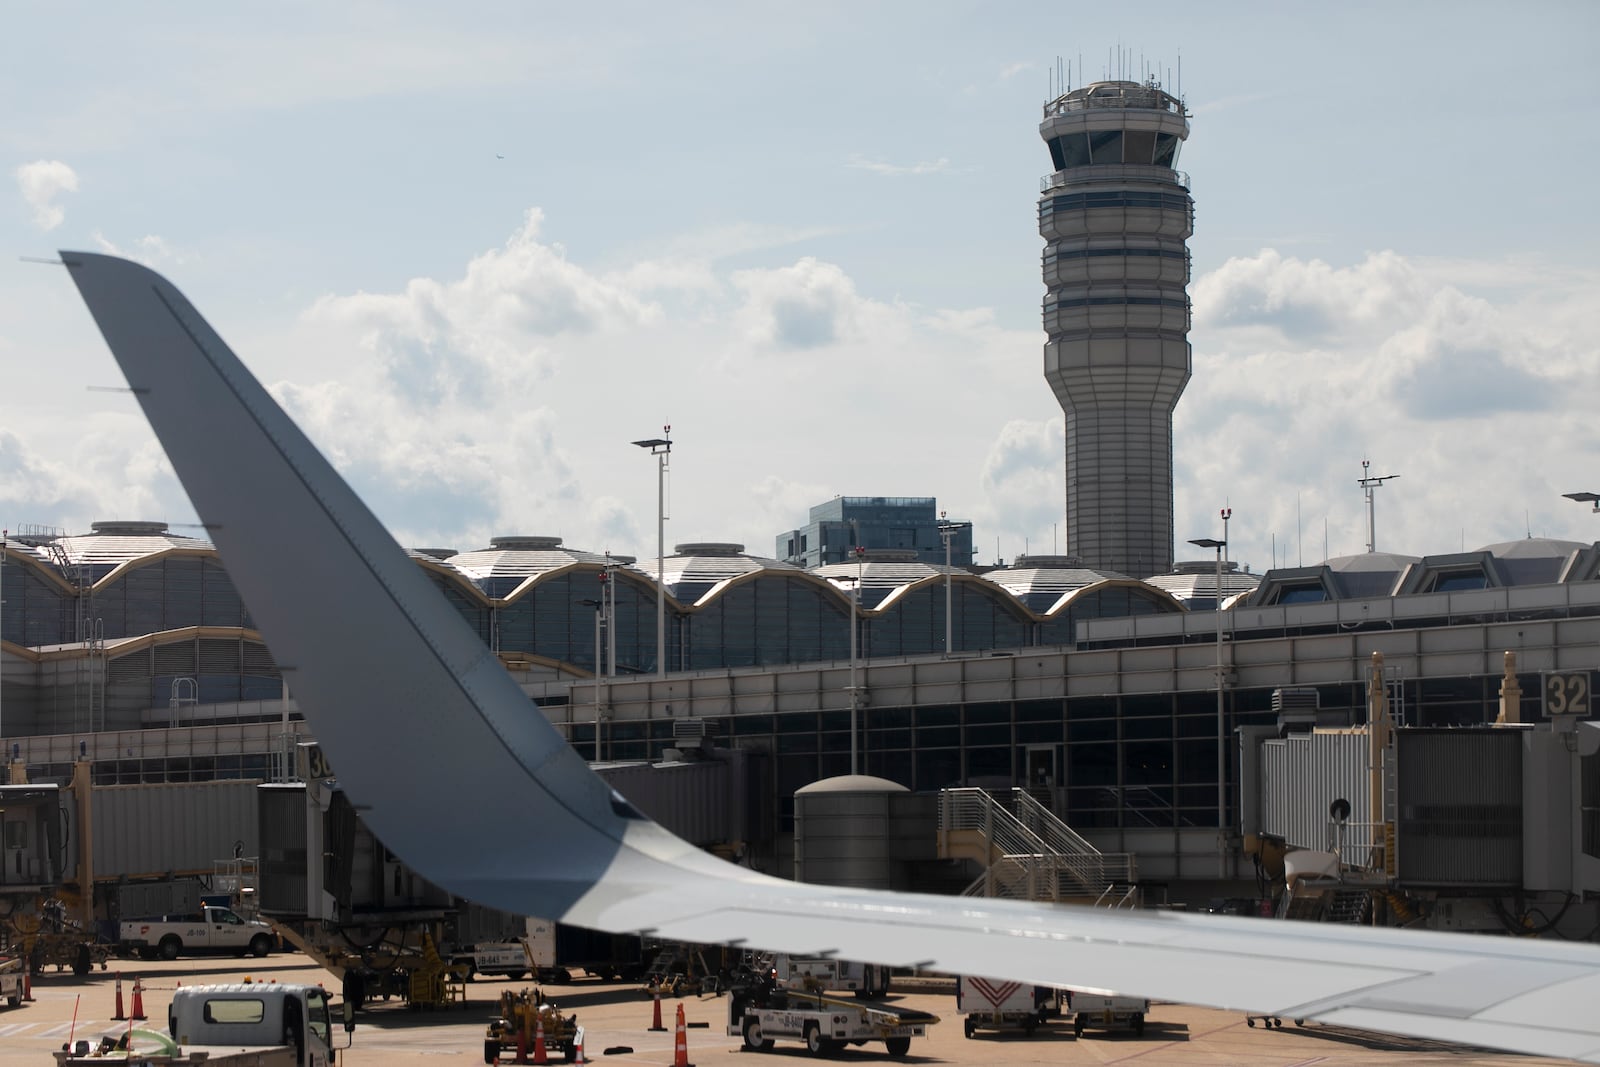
0 0 1600 571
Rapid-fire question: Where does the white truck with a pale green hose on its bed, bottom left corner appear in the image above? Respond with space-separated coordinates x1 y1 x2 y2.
54 982 355 1067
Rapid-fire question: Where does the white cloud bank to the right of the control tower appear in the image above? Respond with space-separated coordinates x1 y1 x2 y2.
1174 250 1600 569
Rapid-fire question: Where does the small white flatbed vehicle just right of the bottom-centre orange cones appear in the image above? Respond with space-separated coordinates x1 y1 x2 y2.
728 974 939 1056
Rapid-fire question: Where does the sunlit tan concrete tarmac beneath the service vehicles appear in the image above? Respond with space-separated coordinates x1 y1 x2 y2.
0 953 1573 1067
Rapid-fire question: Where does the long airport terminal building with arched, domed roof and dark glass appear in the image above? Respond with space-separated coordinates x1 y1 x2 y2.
0 523 1600 896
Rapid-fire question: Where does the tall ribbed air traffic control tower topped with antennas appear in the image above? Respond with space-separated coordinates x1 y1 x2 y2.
1038 82 1194 577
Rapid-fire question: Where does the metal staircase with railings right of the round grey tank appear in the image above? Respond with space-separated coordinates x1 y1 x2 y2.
939 789 1138 904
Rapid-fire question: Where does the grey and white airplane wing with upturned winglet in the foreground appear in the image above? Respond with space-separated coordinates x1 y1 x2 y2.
61 251 1600 1062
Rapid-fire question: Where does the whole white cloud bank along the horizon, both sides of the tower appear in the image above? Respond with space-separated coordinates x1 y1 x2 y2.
18 211 1600 569
